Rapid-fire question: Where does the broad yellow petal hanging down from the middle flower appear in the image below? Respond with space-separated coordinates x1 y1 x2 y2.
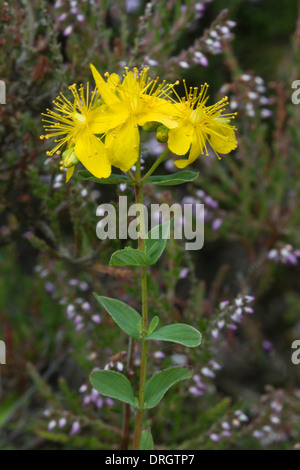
105 118 140 171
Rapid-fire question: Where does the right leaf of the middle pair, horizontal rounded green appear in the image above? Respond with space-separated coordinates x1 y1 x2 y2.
145 323 201 348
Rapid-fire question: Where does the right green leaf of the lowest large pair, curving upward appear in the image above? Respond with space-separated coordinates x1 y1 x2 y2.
144 367 192 410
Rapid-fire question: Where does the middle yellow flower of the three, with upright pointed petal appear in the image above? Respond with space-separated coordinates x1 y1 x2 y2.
91 65 177 171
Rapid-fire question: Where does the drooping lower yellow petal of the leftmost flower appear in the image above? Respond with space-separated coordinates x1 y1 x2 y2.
75 131 111 178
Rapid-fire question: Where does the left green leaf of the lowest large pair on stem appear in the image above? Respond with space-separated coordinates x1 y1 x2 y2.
90 370 138 408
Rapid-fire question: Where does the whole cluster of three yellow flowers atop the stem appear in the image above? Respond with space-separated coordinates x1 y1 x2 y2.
41 65 237 181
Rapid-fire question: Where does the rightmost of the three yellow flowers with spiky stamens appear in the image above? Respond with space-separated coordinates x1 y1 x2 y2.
168 81 237 168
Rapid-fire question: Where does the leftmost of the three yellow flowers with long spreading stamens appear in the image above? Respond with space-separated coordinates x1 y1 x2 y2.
41 85 111 181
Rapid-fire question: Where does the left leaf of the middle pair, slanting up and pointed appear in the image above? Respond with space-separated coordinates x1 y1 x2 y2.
94 293 142 339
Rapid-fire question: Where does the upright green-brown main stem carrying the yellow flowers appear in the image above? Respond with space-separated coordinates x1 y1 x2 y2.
133 157 148 450
